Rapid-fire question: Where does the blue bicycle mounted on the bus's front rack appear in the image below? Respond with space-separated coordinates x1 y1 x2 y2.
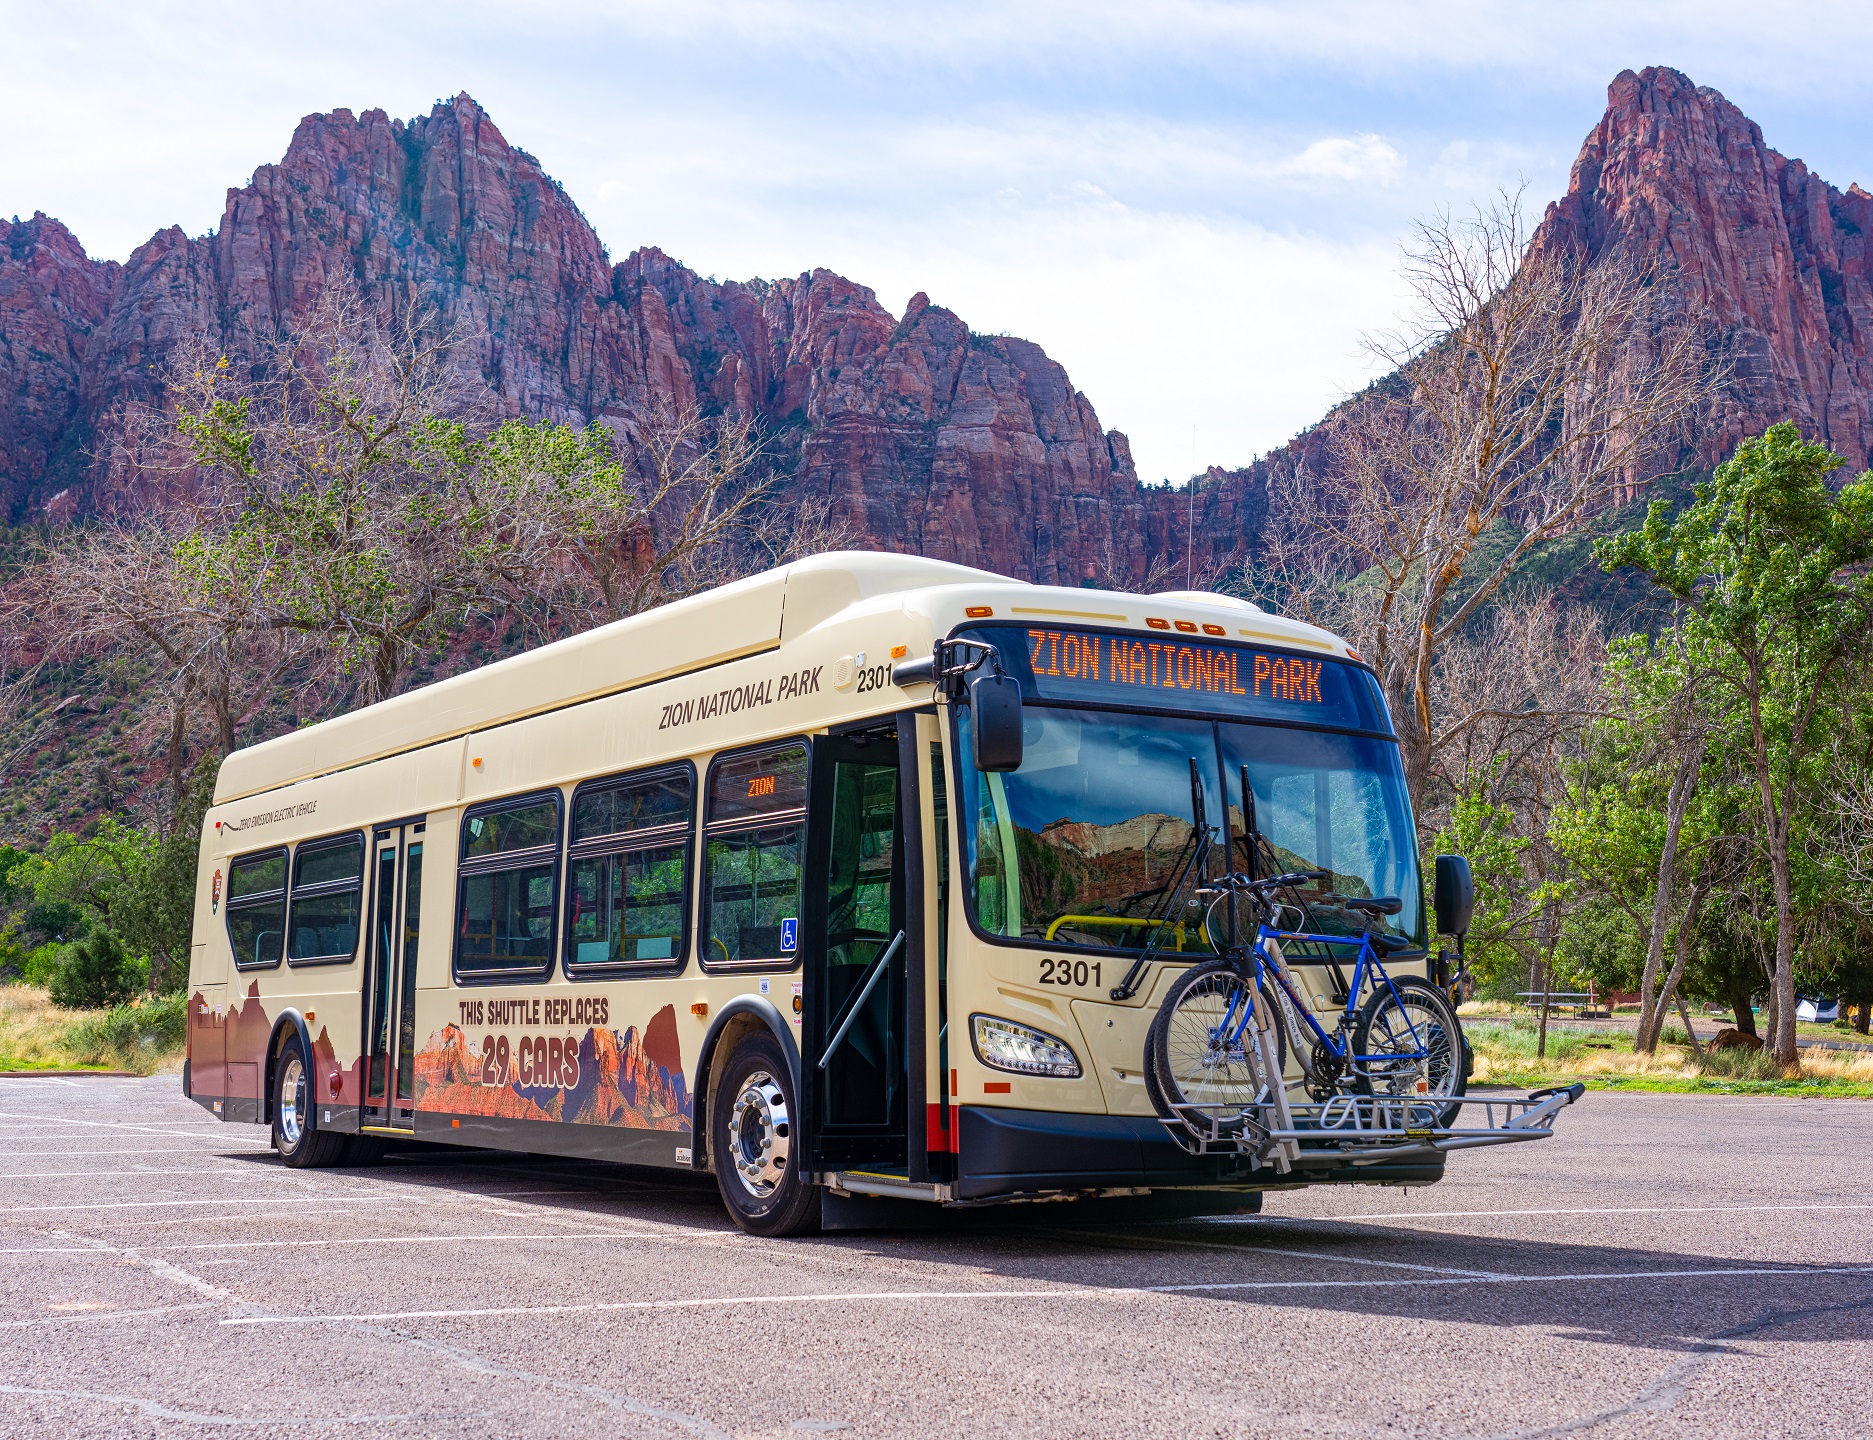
1146 871 1465 1125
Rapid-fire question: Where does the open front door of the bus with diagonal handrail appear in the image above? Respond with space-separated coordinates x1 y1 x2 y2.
802 727 922 1168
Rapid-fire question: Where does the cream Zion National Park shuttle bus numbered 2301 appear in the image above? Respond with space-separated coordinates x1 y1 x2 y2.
184 554 1442 1234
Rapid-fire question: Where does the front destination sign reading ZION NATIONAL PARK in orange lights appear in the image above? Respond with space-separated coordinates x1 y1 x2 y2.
966 625 1392 732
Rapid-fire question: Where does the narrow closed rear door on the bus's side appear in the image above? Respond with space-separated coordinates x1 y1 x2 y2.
360 822 423 1131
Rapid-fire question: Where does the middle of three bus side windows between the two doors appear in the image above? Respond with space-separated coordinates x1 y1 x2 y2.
566 768 695 974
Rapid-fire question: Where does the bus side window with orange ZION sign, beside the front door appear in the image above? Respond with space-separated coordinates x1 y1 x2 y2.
702 745 807 966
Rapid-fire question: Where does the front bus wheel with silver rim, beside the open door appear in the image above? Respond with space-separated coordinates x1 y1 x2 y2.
708 1030 820 1236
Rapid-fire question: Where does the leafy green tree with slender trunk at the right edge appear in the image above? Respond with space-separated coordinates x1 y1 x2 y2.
1596 423 1873 1065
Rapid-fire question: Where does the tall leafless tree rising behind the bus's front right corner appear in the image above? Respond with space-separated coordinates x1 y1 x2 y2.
1274 197 1718 801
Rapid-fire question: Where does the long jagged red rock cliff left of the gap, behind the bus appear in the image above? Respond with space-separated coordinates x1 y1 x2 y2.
0 96 1143 582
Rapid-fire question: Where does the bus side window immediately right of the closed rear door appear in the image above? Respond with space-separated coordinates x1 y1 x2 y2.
455 792 560 979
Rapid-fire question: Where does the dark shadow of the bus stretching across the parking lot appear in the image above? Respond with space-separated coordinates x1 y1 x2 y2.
242 1146 1873 1354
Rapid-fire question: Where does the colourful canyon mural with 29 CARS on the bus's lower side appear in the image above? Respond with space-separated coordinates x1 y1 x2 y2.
416 1006 695 1131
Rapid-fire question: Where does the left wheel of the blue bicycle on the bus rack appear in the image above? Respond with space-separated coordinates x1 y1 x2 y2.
1144 961 1285 1118
